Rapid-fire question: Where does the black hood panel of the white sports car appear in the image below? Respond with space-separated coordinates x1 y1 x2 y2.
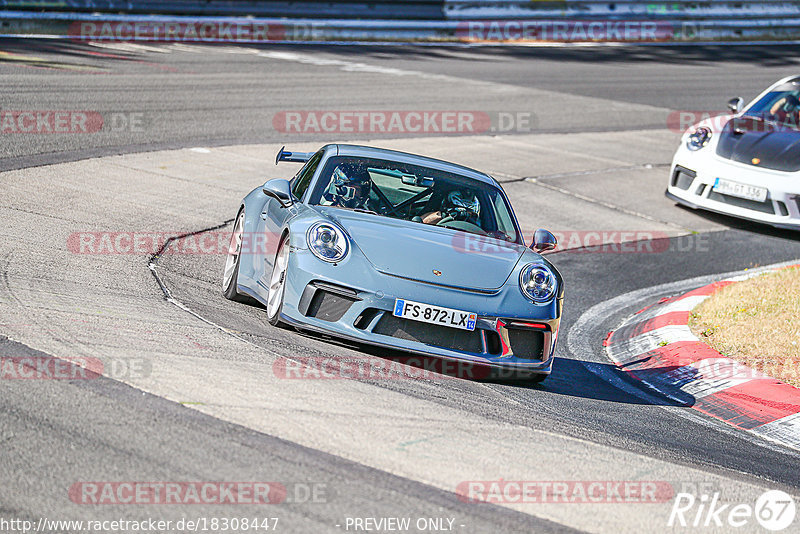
717 117 800 172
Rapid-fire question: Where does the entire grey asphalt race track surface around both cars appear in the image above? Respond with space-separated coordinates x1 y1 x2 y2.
0 40 800 532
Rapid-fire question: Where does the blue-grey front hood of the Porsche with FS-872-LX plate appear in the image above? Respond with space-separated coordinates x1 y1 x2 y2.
320 208 527 290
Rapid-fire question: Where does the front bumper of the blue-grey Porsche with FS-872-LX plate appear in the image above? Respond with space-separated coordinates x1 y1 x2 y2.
272 249 562 374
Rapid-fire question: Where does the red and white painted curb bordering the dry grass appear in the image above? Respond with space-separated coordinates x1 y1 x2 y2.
603 273 800 450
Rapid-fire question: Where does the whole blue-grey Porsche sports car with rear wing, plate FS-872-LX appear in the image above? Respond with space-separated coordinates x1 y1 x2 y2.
223 144 564 382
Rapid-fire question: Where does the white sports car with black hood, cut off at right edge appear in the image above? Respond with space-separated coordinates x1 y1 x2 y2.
666 76 800 230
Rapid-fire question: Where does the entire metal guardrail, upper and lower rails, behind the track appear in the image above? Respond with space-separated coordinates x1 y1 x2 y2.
0 0 800 44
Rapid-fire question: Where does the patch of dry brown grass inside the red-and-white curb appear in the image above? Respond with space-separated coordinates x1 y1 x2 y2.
689 268 800 387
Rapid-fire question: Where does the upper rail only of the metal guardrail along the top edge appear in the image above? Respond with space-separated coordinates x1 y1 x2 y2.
6 0 800 20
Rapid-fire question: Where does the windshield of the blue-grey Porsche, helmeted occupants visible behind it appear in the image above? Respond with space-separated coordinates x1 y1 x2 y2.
310 156 520 243
